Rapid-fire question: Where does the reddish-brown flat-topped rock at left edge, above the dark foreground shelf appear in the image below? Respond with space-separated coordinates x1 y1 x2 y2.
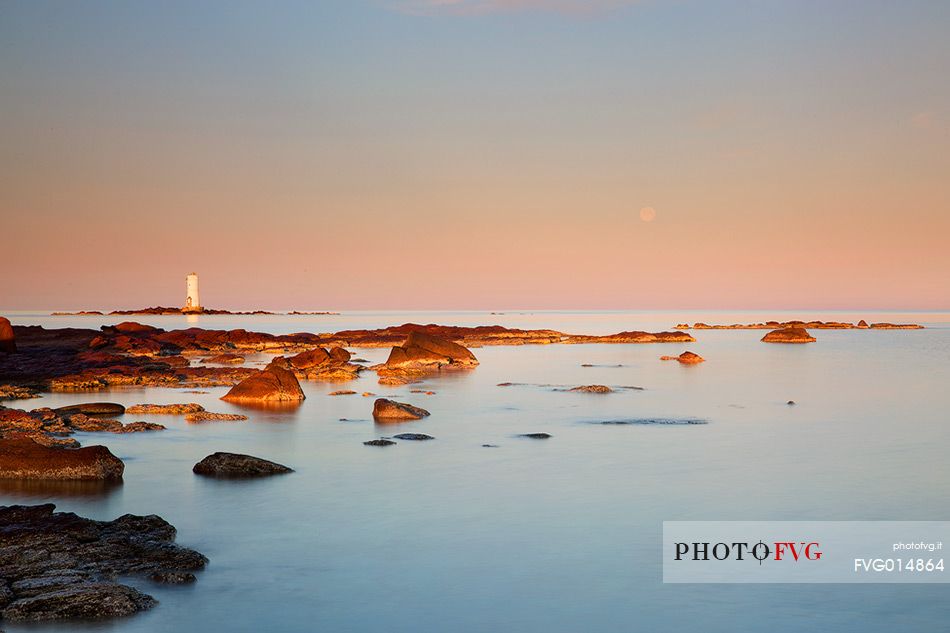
0 439 125 480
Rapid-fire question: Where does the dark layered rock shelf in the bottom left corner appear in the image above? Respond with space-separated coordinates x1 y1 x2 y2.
0 504 208 621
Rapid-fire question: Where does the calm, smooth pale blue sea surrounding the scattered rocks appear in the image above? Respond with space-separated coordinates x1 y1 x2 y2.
0 312 950 633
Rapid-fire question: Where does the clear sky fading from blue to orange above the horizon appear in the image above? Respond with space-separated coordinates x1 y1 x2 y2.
0 0 950 310
